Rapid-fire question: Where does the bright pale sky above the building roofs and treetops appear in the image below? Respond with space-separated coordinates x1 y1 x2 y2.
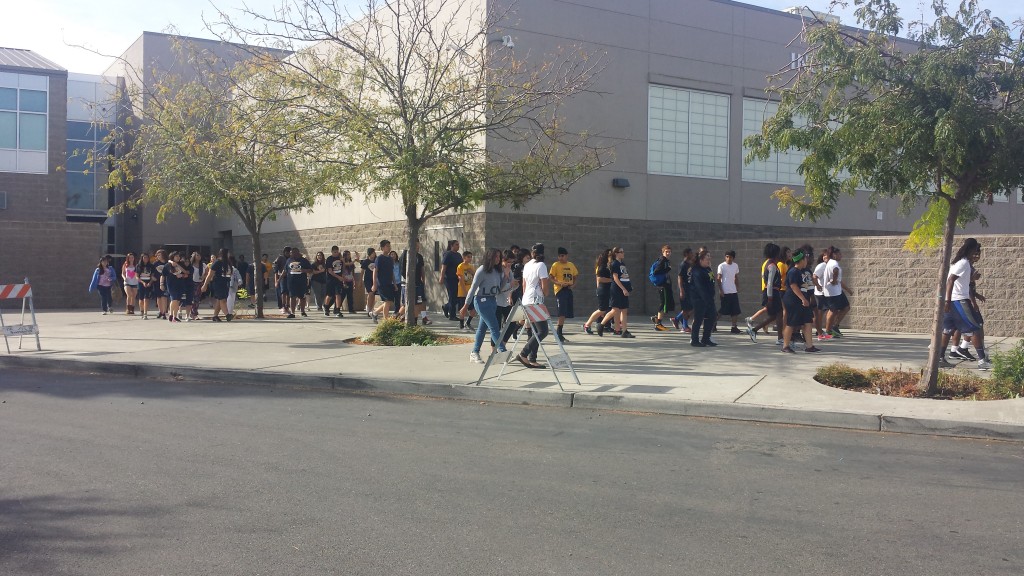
0 0 1024 74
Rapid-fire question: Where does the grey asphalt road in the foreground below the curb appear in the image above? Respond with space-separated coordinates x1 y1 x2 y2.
0 366 1024 576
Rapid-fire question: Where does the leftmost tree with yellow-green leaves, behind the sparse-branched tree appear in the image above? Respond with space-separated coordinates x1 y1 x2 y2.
109 48 343 318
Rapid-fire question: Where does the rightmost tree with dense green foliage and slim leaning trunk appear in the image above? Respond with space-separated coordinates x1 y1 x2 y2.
746 0 1024 393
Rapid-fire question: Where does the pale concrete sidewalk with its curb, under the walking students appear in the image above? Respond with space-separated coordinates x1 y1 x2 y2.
0 308 1024 440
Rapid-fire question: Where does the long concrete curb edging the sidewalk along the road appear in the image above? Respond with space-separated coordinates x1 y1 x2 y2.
0 356 1024 442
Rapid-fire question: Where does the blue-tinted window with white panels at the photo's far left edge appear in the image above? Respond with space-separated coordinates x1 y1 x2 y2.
0 73 49 174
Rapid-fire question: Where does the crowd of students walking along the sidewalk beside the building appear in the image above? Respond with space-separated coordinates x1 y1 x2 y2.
90 234 988 369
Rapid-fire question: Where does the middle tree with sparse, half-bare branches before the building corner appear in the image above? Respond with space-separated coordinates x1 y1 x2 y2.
217 0 609 323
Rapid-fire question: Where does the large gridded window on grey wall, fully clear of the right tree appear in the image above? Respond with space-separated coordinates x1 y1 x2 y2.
647 86 729 179
